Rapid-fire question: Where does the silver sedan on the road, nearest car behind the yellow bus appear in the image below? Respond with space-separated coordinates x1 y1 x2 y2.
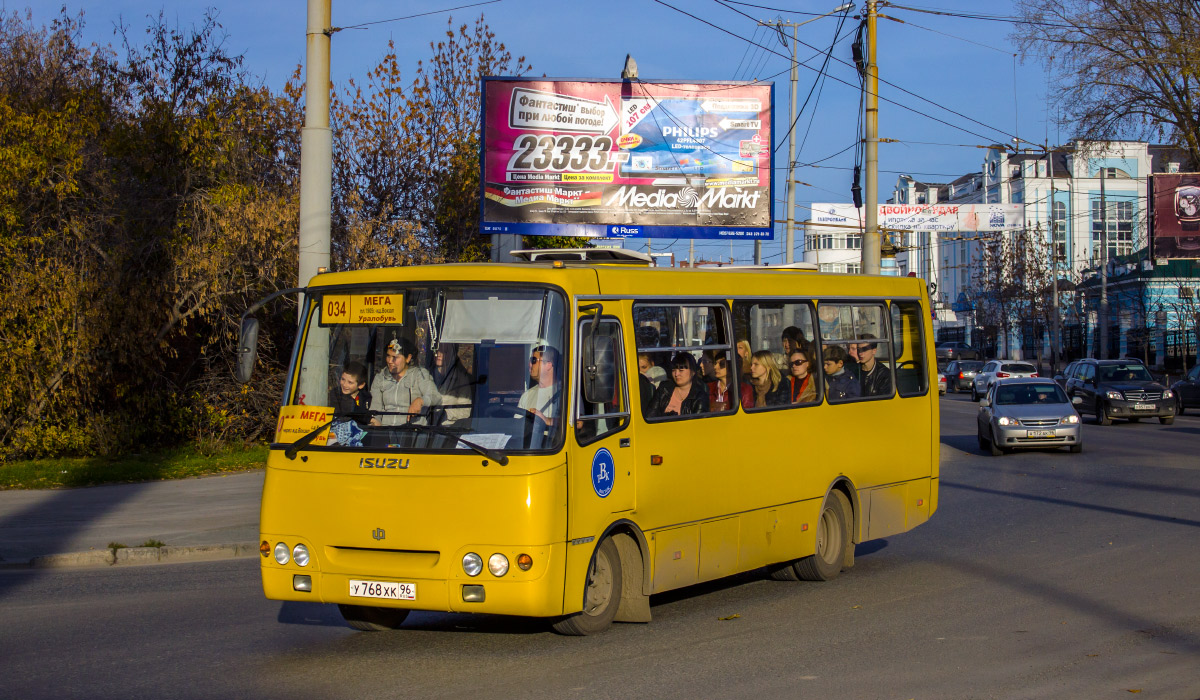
976 378 1084 456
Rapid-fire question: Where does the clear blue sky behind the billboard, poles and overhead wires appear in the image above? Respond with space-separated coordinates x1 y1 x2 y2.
28 0 1070 262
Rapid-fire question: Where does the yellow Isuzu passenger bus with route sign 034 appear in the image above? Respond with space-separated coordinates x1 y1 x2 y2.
240 250 938 634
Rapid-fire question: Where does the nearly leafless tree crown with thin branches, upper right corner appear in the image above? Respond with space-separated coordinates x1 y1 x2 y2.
1010 0 1200 169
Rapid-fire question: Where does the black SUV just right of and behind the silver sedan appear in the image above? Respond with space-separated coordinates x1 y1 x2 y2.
1055 359 1175 425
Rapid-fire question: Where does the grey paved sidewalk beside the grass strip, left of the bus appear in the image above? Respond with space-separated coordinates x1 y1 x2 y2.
0 469 264 567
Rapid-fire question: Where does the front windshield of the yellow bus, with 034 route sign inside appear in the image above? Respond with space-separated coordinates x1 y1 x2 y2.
292 285 566 453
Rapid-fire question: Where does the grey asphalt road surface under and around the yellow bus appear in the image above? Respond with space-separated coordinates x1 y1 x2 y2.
0 396 1200 700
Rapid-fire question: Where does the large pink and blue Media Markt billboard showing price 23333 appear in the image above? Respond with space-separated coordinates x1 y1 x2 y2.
480 78 774 240
